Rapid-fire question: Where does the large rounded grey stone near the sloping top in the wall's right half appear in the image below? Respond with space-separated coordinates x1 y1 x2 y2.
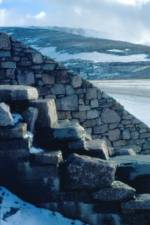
101 109 121 123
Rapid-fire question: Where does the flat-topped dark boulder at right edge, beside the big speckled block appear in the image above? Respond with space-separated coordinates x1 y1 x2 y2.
111 155 150 193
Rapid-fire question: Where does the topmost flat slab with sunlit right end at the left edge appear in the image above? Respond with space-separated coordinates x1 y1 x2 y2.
0 85 38 102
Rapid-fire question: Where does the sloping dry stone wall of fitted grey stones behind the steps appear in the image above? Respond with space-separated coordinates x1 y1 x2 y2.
0 33 150 153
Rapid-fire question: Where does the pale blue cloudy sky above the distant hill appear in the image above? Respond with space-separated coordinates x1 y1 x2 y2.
0 0 150 44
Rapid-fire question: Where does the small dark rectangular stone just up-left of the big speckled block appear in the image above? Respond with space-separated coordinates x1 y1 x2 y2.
31 151 63 166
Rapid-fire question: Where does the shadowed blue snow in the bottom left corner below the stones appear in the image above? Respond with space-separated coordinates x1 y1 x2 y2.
0 187 83 225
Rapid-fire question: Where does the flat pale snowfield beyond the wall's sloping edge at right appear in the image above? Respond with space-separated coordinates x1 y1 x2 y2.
93 80 150 127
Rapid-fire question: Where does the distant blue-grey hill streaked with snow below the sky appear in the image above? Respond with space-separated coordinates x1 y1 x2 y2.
0 27 150 80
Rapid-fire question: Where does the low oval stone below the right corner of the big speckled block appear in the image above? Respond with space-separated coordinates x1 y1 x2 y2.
93 181 136 202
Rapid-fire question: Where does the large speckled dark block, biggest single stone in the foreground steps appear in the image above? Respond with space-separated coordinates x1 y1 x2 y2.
66 154 116 190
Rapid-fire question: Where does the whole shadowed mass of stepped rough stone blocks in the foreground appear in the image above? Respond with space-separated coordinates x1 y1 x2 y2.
0 85 150 225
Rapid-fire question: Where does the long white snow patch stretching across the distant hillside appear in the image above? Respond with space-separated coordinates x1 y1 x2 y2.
33 46 150 63
